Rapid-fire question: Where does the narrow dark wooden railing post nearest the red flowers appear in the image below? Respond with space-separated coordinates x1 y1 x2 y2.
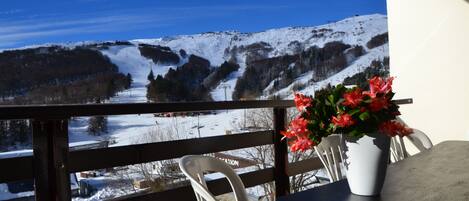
274 108 290 197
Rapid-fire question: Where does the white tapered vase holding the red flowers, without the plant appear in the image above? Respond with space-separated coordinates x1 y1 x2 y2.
345 133 390 196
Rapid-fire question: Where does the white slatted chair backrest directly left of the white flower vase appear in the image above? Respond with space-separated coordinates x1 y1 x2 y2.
314 134 344 182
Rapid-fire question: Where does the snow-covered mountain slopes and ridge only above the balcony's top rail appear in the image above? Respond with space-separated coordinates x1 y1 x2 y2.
1 14 388 102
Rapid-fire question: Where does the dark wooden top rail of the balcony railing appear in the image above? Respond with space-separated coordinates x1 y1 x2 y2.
0 99 412 120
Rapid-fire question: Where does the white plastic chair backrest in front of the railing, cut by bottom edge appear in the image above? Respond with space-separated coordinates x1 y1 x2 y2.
179 155 248 201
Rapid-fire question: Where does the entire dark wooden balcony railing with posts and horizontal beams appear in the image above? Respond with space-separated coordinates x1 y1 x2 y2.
0 99 412 201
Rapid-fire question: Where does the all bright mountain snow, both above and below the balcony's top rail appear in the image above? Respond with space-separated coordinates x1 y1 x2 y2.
0 14 388 148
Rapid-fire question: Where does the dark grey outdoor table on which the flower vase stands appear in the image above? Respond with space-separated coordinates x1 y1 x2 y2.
277 141 469 201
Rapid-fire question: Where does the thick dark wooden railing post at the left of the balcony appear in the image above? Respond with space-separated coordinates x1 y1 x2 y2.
32 119 71 201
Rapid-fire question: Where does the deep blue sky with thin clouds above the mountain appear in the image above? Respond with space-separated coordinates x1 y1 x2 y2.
0 0 386 49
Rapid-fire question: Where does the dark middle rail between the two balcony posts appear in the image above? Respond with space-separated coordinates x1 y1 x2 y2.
70 131 273 172
